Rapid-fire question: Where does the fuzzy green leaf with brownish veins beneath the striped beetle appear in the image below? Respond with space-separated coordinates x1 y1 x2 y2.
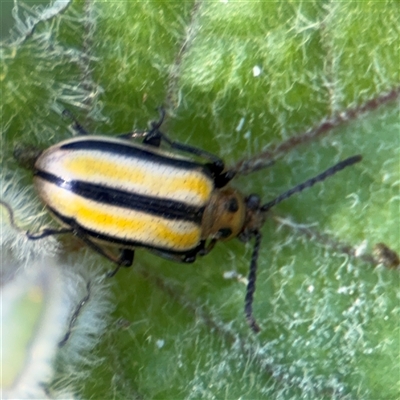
1 1 400 399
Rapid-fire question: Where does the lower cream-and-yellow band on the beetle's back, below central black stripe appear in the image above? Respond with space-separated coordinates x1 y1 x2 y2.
42 183 201 251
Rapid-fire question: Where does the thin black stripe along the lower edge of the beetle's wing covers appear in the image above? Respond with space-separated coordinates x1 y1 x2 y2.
48 207 204 255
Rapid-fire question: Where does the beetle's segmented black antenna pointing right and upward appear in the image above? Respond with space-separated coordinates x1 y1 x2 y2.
260 155 362 212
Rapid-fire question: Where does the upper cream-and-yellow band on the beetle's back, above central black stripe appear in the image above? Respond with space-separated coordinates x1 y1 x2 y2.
40 149 213 207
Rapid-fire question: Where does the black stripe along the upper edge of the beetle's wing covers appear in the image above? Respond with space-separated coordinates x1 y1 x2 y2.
60 139 211 173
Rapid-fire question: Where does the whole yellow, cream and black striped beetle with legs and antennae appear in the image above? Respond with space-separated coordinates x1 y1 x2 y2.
7 112 361 332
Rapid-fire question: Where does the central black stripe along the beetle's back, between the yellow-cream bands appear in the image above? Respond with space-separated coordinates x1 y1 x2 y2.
35 170 204 224
